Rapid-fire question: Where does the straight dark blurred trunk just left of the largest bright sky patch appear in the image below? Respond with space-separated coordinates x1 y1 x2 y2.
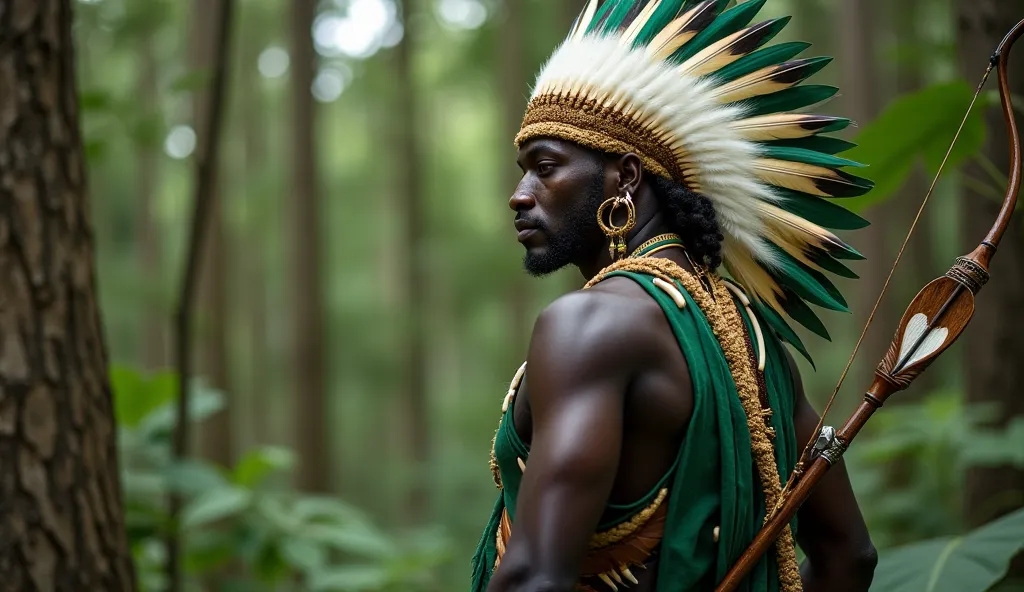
292 0 332 492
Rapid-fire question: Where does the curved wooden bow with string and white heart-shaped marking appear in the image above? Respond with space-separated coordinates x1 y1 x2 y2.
716 19 1024 592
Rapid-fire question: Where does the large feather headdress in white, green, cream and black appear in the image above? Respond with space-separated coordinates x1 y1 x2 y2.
516 0 871 357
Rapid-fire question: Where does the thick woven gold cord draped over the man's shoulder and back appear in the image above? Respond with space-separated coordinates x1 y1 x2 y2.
584 258 803 592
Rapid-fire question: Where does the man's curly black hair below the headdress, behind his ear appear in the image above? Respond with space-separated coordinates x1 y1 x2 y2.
647 175 724 270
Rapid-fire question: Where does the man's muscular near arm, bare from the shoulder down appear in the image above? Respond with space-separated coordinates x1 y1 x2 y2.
488 291 632 592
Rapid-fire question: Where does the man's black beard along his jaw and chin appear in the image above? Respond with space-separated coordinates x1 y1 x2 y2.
522 174 604 277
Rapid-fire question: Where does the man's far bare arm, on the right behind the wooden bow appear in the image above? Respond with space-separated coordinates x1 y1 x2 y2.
790 348 878 592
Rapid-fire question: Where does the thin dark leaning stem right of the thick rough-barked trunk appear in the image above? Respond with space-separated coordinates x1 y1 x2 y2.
166 0 234 592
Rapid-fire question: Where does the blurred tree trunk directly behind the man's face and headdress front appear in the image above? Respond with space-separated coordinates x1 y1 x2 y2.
496 2 532 357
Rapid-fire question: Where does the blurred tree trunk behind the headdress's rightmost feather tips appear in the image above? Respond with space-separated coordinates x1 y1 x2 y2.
837 0 895 378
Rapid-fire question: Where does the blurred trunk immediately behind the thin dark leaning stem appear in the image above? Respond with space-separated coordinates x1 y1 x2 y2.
190 0 233 467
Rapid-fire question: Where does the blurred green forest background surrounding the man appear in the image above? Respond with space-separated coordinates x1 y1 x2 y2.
6 0 1024 591
